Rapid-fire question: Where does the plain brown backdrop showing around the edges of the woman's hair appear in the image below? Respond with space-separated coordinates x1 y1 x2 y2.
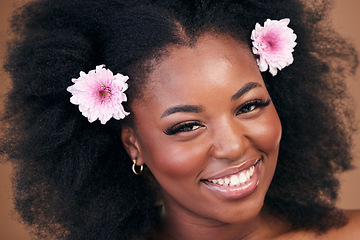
0 0 360 240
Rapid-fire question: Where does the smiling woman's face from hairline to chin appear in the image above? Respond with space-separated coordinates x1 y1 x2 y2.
124 36 281 223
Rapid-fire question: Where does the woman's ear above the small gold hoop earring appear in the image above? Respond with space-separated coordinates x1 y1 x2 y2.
121 127 144 165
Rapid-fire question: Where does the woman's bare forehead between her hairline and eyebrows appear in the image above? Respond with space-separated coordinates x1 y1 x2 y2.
134 35 263 107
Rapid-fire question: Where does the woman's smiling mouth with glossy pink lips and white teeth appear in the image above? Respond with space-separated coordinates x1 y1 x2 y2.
202 158 263 199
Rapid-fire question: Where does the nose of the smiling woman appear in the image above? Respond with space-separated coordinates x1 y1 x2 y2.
210 119 250 160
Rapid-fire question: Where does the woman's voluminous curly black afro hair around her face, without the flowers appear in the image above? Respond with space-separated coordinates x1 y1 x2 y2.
0 0 357 240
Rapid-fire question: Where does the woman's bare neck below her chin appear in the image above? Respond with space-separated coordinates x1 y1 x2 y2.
156 204 288 240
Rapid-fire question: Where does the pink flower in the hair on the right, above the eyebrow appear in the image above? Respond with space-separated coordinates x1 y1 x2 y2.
251 18 296 76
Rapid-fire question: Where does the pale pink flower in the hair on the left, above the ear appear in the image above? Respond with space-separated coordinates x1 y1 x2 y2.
67 65 129 124
